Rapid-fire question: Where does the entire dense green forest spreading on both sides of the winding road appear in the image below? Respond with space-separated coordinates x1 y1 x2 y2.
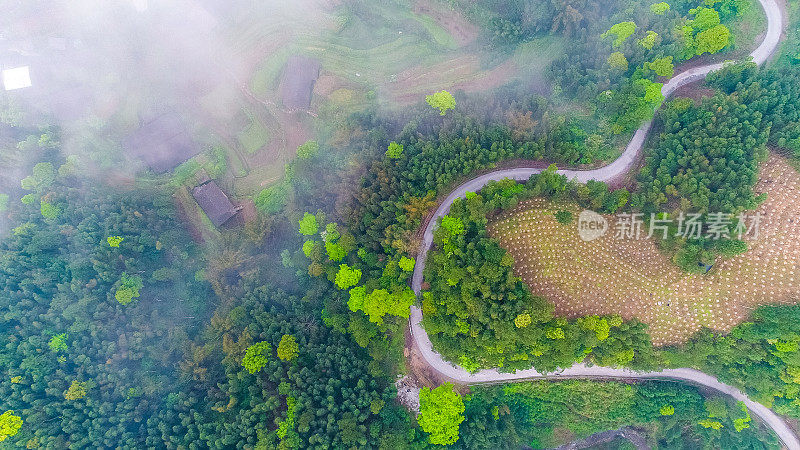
0 0 800 449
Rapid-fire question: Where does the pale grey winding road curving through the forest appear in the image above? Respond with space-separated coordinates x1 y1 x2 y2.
409 0 800 450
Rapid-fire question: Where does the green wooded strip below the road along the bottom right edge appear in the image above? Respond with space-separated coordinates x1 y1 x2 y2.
456 381 780 449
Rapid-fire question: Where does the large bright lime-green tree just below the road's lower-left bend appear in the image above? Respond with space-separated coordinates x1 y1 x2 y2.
417 383 465 445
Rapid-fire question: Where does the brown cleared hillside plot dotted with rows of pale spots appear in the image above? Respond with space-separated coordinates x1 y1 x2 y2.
489 156 800 345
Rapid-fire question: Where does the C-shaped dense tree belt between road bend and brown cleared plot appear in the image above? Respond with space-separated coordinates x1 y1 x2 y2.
422 176 653 371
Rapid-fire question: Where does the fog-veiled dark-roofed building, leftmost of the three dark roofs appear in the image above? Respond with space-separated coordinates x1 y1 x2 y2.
124 112 200 173
